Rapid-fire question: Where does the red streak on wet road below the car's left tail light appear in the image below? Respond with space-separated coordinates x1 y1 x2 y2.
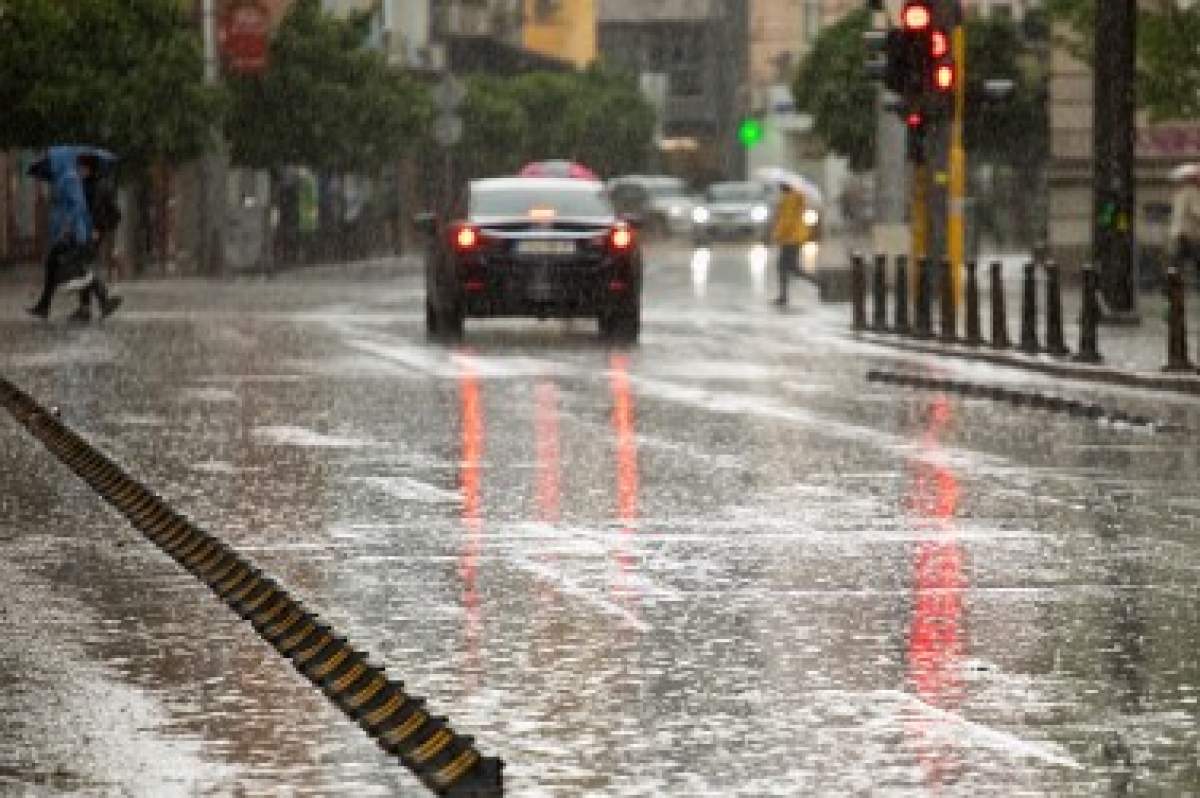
458 364 485 689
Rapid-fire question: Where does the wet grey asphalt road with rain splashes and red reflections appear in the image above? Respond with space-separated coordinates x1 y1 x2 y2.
0 242 1200 797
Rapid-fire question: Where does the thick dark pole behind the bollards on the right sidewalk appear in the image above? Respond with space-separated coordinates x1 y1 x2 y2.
1092 0 1139 324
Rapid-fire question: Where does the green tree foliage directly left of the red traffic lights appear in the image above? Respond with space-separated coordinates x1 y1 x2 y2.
792 7 876 172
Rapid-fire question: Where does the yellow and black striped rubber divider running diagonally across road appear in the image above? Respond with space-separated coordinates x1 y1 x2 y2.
0 377 504 798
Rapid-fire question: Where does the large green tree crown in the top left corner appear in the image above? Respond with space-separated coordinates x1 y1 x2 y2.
0 0 222 166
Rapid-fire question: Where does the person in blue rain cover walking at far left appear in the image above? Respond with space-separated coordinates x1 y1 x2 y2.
29 148 95 319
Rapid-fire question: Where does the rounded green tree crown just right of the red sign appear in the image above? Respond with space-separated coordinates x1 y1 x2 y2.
226 0 431 173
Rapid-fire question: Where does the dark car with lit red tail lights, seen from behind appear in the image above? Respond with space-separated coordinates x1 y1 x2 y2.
425 178 642 342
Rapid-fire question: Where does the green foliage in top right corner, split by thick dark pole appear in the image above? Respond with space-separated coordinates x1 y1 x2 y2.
1046 0 1200 120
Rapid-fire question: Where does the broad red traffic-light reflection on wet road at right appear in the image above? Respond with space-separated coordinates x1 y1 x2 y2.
908 396 967 786
